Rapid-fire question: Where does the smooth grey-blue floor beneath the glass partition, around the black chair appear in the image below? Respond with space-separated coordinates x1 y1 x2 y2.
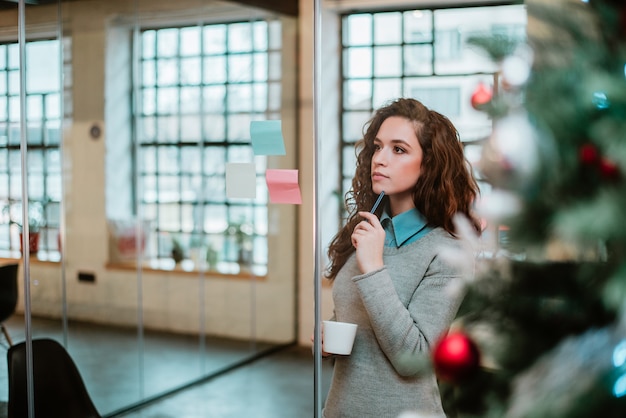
0 316 332 418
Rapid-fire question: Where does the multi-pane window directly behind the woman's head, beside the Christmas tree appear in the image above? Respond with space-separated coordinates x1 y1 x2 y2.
341 5 526 217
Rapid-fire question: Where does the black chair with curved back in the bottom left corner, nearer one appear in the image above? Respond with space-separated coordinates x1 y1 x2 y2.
7 338 101 418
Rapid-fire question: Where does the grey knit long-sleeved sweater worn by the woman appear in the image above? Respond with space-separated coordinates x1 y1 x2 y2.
323 228 463 418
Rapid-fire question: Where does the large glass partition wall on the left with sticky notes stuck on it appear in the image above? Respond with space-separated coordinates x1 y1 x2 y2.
0 0 297 416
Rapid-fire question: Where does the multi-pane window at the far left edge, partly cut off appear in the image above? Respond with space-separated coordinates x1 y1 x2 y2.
0 40 63 260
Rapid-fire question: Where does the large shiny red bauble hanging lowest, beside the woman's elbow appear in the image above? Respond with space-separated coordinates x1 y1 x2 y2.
433 332 480 382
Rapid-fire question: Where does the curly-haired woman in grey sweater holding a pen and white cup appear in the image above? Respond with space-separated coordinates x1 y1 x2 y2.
322 99 480 418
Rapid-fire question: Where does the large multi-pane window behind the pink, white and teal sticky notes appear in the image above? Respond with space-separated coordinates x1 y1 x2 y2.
136 21 281 275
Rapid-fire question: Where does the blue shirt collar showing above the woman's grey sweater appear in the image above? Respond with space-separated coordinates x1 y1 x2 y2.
380 208 432 248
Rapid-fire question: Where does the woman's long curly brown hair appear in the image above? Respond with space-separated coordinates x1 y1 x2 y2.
326 98 481 280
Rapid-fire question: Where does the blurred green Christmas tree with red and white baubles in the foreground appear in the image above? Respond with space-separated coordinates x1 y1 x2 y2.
432 0 626 418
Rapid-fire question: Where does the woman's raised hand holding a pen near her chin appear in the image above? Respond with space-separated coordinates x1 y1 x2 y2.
352 212 385 274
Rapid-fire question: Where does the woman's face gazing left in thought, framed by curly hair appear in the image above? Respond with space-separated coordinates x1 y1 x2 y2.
372 116 423 216
